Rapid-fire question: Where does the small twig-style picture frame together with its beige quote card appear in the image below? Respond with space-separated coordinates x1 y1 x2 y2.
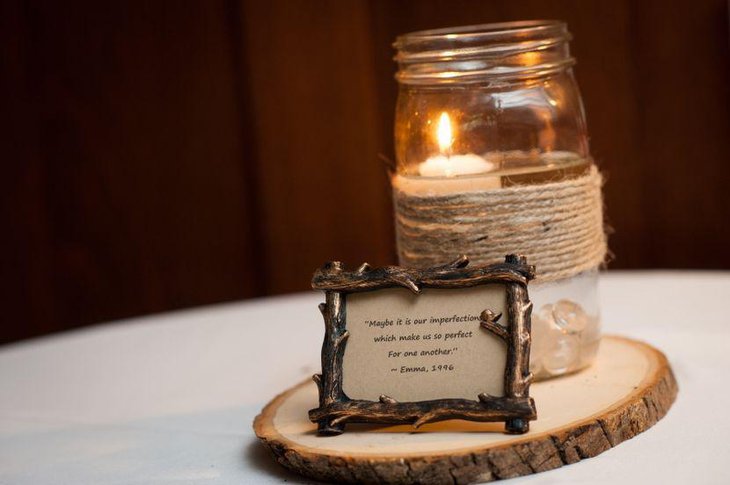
309 255 536 435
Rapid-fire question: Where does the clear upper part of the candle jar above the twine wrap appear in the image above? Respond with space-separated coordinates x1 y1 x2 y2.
395 21 589 180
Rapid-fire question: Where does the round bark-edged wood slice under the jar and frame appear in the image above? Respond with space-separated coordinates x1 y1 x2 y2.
254 337 677 484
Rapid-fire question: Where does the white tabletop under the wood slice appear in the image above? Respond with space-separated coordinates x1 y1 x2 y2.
0 271 730 485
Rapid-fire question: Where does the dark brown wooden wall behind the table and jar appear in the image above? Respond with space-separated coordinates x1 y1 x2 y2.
0 0 730 342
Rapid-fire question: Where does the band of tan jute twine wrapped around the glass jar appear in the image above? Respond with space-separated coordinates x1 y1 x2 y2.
393 166 607 282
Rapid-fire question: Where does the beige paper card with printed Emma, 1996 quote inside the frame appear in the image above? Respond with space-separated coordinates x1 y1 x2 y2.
342 284 508 402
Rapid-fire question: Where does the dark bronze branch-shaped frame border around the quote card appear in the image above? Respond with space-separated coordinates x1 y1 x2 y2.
309 255 537 435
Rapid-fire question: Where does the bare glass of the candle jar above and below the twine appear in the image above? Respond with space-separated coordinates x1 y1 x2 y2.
392 21 605 378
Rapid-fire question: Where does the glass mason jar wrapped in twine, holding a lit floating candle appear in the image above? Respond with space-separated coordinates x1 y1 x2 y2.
392 21 606 378
